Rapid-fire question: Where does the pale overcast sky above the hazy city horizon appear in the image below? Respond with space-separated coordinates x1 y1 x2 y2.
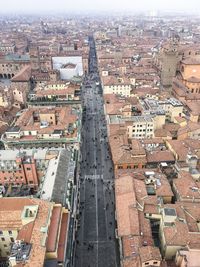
0 0 200 13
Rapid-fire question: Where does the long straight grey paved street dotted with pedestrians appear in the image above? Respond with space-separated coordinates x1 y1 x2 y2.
75 38 119 267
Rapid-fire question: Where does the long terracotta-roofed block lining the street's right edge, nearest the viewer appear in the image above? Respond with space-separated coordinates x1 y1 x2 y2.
115 174 162 267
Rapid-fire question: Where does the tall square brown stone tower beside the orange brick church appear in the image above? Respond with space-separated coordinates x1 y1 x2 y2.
160 38 179 88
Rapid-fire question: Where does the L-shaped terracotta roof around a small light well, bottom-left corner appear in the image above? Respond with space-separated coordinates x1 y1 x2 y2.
0 197 53 267
